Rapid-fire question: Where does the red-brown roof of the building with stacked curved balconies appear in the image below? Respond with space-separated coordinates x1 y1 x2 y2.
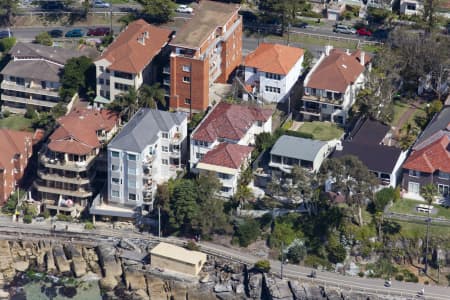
48 108 118 155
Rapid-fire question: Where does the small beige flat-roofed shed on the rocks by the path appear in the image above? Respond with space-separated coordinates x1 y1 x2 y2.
150 243 206 276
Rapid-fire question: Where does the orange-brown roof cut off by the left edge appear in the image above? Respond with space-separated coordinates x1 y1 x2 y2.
0 128 33 170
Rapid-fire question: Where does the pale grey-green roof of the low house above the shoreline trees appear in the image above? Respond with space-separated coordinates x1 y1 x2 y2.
270 135 328 161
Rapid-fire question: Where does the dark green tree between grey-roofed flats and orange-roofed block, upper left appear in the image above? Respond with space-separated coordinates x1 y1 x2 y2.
59 56 96 102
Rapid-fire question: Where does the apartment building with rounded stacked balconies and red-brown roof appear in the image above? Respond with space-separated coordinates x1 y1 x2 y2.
34 108 119 216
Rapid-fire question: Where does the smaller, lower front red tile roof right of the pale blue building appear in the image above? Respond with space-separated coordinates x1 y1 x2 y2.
200 143 254 169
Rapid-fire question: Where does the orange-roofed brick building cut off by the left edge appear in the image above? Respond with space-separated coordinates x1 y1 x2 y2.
0 128 34 205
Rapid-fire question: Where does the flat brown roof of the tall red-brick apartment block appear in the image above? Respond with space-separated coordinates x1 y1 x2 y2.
170 1 239 48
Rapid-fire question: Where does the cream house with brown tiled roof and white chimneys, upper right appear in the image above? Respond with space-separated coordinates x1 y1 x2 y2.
300 46 371 125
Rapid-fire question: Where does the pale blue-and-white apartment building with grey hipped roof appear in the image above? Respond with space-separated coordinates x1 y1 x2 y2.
107 109 187 212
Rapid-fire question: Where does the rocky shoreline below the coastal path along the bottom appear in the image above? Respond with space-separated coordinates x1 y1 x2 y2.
0 240 412 300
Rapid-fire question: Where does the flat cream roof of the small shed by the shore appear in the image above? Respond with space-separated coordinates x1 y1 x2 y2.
150 243 206 265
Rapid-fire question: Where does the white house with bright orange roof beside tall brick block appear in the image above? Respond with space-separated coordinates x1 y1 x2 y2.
244 43 304 103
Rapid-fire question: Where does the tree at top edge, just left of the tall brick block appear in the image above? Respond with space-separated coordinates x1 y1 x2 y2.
138 0 176 24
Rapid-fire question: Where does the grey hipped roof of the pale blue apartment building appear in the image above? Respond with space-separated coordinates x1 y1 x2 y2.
108 108 187 153
